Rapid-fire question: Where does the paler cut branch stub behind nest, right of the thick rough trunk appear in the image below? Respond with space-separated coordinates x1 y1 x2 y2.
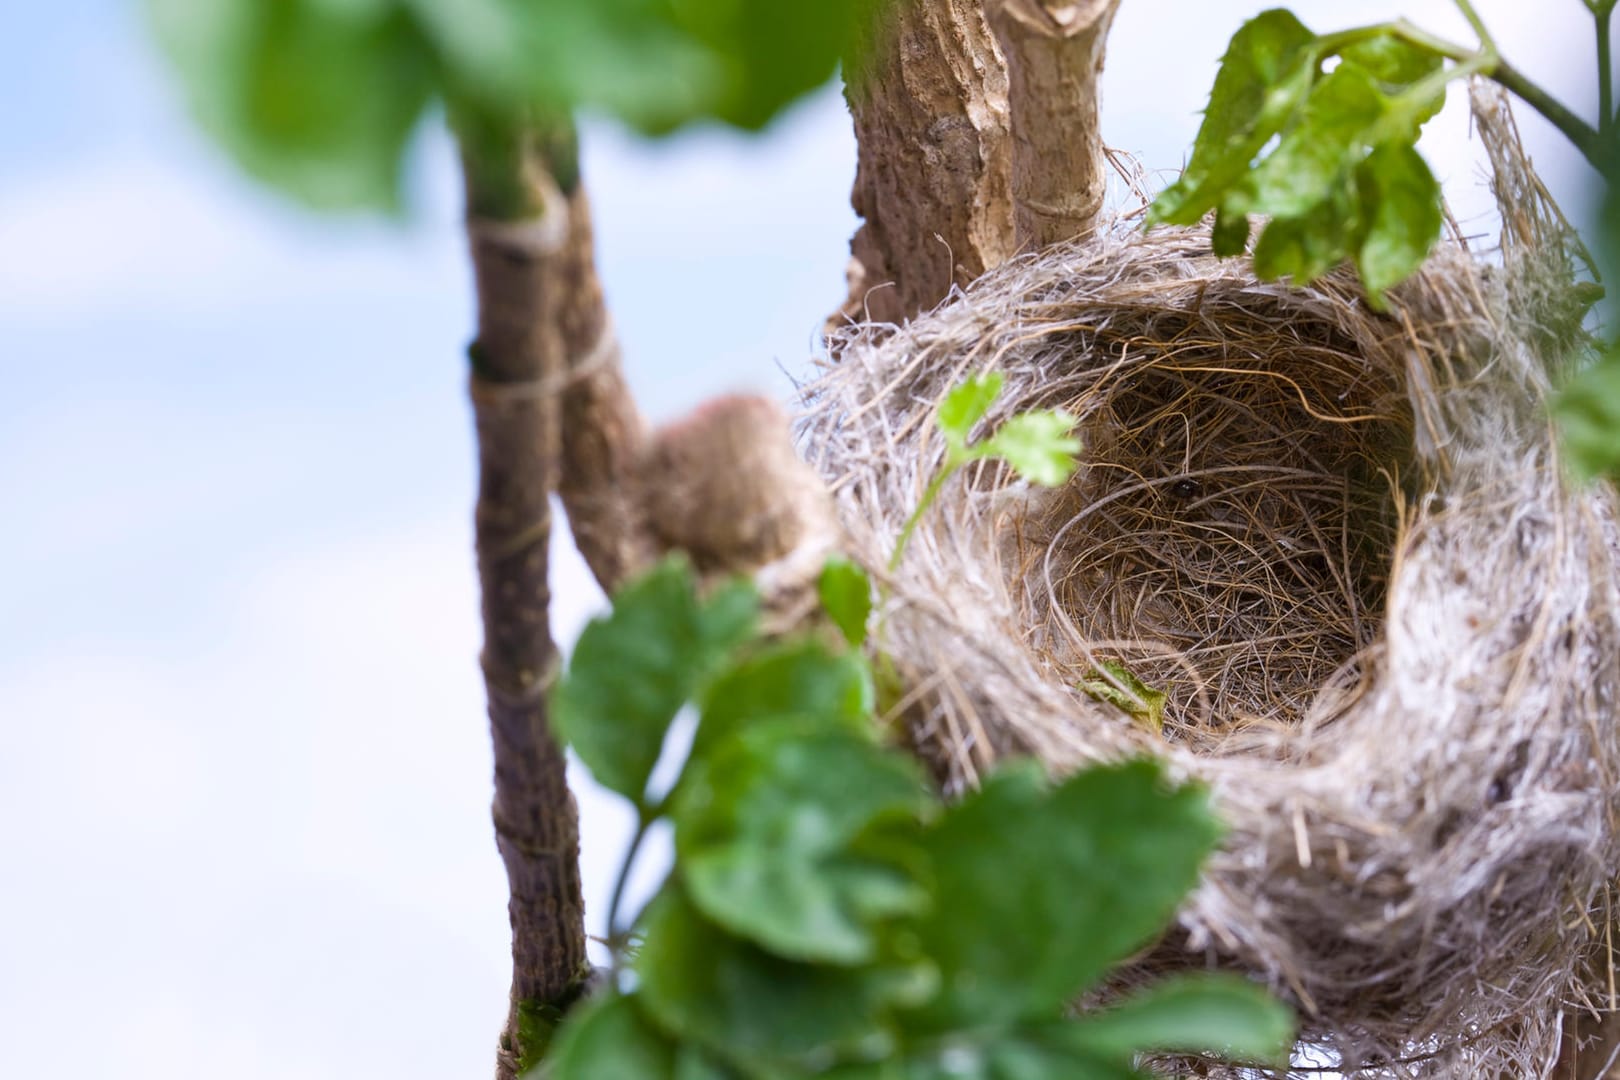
985 0 1119 251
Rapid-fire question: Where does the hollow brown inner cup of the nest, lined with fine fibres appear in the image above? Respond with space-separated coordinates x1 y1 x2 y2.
1009 308 1413 740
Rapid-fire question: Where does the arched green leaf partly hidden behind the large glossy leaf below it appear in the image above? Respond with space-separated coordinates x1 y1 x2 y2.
692 638 873 758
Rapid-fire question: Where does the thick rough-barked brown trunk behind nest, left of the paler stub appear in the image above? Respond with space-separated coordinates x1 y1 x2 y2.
834 0 1013 322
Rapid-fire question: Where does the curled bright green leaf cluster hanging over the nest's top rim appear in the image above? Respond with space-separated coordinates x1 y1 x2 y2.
1149 10 1447 308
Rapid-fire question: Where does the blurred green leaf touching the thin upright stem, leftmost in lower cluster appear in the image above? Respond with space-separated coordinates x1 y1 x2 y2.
551 559 758 805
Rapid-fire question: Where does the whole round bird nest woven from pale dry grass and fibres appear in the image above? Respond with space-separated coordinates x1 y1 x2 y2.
802 88 1620 1078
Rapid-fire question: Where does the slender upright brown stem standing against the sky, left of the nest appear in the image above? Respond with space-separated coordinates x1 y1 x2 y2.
467 128 588 1080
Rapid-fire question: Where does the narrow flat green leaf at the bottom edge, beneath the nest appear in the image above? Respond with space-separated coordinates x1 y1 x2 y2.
1048 975 1294 1065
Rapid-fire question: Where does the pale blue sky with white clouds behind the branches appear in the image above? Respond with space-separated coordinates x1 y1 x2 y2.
0 0 1594 1080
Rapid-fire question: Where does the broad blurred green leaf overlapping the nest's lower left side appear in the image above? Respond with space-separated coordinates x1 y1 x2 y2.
914 761 1220 1031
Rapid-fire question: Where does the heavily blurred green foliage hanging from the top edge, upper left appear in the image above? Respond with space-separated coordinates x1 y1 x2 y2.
147 0 886 209
